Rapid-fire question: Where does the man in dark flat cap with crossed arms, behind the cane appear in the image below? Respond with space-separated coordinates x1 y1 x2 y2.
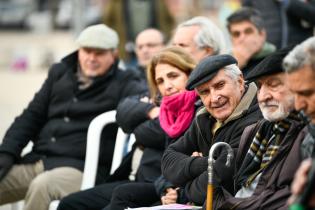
162 55 261 205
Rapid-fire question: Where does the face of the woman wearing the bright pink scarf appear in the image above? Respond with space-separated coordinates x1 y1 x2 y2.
155 64 188 96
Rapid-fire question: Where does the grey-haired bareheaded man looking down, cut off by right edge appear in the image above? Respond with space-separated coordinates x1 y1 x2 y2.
283 37 315 208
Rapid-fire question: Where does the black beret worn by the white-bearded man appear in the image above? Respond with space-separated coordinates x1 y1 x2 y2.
246 46 293 82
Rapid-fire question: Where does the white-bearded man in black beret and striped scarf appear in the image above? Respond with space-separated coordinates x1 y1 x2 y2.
215 48 306 210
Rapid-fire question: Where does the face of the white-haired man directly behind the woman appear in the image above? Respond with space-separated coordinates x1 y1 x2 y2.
172 26 212 61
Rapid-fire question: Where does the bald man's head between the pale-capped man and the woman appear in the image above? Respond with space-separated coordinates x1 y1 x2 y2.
135 28 165 67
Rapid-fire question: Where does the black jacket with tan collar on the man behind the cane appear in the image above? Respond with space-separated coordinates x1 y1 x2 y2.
162 84 261 205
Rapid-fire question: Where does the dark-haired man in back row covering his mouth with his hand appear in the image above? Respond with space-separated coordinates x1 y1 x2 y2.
227 8 276 79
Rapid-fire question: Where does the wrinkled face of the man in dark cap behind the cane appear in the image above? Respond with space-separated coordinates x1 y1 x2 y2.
196 69 245 122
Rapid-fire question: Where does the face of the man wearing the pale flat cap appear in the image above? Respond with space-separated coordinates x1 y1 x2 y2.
79 48 115 77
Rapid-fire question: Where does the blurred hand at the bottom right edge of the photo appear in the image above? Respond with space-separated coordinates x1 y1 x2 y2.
288 159 315 207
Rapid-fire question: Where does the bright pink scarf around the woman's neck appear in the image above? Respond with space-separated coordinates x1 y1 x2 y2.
160 90 197 138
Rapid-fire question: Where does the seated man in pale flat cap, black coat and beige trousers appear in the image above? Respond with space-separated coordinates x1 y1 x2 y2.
0 24 144 210
